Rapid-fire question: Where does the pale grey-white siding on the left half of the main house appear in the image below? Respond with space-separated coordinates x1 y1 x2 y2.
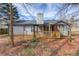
13 26 33 35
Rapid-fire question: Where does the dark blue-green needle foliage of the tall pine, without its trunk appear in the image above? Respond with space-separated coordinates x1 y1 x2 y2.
0 3 19 20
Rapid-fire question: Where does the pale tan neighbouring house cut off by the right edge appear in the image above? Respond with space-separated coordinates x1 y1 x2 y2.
67 19 79 35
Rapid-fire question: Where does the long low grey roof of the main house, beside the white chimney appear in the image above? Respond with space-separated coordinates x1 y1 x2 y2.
6 20 69 26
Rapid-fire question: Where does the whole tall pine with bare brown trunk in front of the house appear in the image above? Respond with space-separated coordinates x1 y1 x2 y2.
0 3 19 46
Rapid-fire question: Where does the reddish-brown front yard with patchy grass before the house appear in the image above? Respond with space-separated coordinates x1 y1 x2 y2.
0 36 79 56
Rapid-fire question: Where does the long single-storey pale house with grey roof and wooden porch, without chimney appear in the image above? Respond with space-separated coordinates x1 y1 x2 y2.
6 20 69 38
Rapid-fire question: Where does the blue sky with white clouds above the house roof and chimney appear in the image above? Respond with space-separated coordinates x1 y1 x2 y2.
13 3 79 20
